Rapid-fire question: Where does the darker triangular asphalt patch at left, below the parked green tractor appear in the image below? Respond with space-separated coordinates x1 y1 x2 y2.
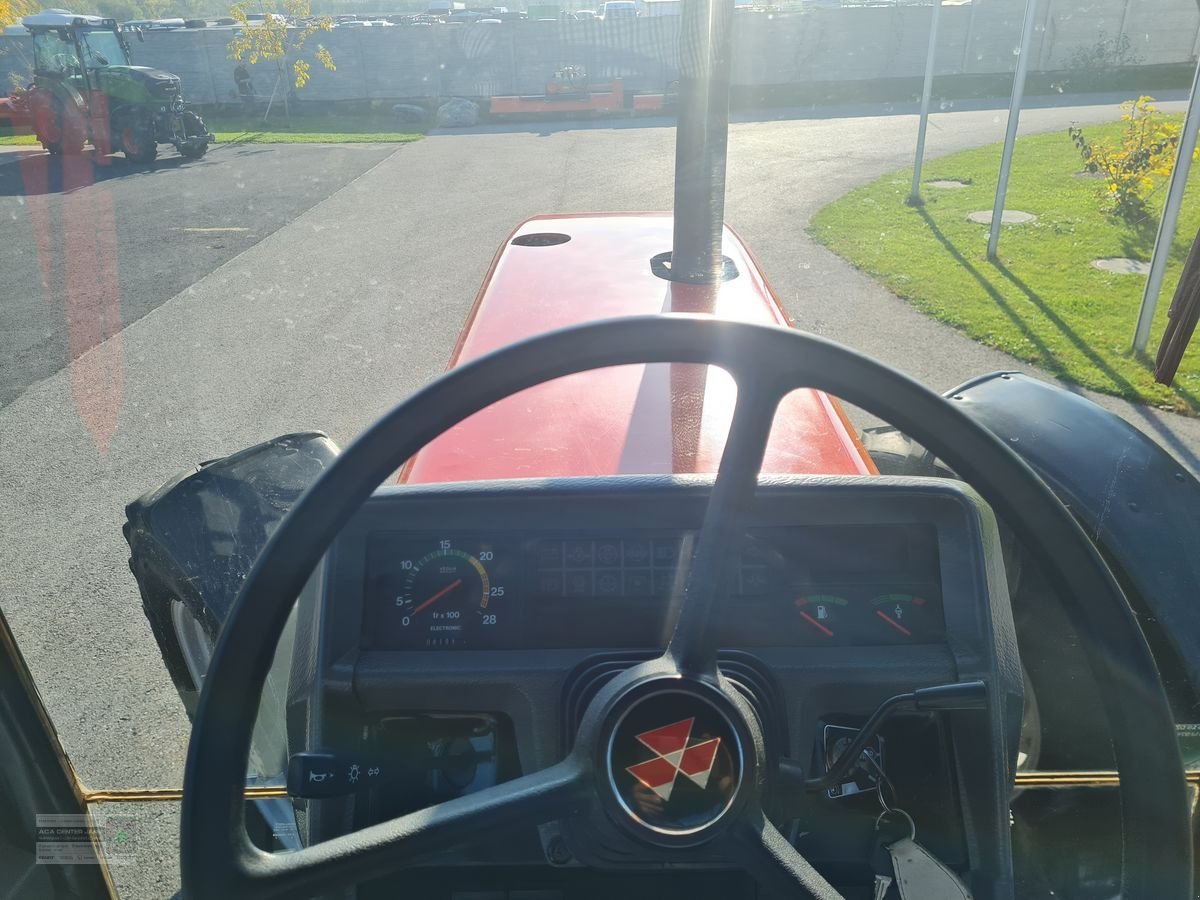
0 144 395 407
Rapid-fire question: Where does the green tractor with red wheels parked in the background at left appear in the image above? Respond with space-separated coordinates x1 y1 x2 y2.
22 10 214 163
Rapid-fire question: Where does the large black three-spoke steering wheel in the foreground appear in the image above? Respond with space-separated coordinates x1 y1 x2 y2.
181 314 1192 900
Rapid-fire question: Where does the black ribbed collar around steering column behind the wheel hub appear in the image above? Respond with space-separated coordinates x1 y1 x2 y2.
563 650 787 755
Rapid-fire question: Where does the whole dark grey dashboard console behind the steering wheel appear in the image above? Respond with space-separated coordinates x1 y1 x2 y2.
287 476 1022 896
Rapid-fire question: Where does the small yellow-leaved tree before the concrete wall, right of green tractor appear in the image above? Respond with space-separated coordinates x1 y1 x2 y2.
226 0 337 120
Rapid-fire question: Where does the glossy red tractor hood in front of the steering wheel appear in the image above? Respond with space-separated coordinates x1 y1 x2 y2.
401 214 875 482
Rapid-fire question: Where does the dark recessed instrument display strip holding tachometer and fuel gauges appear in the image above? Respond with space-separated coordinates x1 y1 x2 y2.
362 523 946 650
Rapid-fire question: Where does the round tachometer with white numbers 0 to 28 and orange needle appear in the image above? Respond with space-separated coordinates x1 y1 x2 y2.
391 541 504 649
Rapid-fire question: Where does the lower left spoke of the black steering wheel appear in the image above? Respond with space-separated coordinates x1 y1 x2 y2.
232 755 590 898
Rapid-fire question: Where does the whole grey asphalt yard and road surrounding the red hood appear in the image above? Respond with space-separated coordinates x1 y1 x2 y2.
0 97 1200 896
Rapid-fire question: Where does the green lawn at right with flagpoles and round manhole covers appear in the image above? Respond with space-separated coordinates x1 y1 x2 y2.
809 115 1200 415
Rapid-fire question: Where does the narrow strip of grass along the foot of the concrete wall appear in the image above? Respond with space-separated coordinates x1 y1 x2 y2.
0 110 424 146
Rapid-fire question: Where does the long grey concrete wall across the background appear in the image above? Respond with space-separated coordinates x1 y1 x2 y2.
0 0 1200 103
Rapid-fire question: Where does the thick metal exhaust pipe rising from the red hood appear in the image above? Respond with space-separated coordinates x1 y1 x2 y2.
671 0 733 284
